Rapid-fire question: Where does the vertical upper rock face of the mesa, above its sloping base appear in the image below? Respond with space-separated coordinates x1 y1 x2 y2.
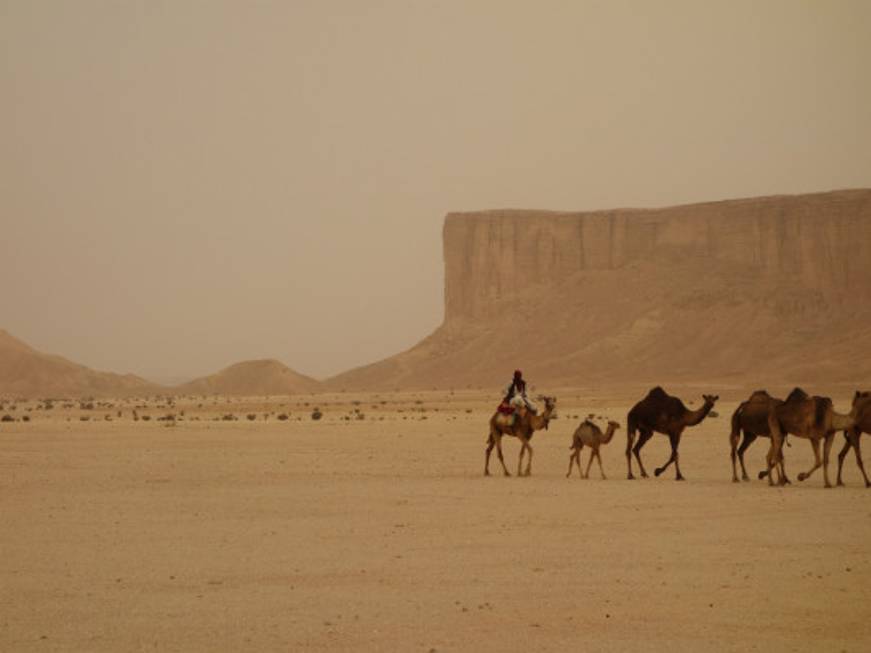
444 189 871 323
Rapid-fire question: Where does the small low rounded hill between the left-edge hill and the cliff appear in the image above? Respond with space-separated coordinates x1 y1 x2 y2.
173 359 321 397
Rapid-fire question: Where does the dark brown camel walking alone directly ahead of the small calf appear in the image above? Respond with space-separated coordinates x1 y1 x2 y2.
626 386 719 481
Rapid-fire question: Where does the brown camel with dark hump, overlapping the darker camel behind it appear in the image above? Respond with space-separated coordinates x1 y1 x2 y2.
768 388 855 488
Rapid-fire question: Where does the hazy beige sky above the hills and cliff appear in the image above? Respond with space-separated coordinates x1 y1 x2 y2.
0 0 871 379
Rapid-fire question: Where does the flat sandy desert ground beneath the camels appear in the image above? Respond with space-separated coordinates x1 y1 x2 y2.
0 393 871 652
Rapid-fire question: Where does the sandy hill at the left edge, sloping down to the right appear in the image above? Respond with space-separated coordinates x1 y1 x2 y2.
0 330 165 398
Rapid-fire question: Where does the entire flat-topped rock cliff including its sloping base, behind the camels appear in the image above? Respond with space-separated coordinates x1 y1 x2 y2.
330 190 871 389
